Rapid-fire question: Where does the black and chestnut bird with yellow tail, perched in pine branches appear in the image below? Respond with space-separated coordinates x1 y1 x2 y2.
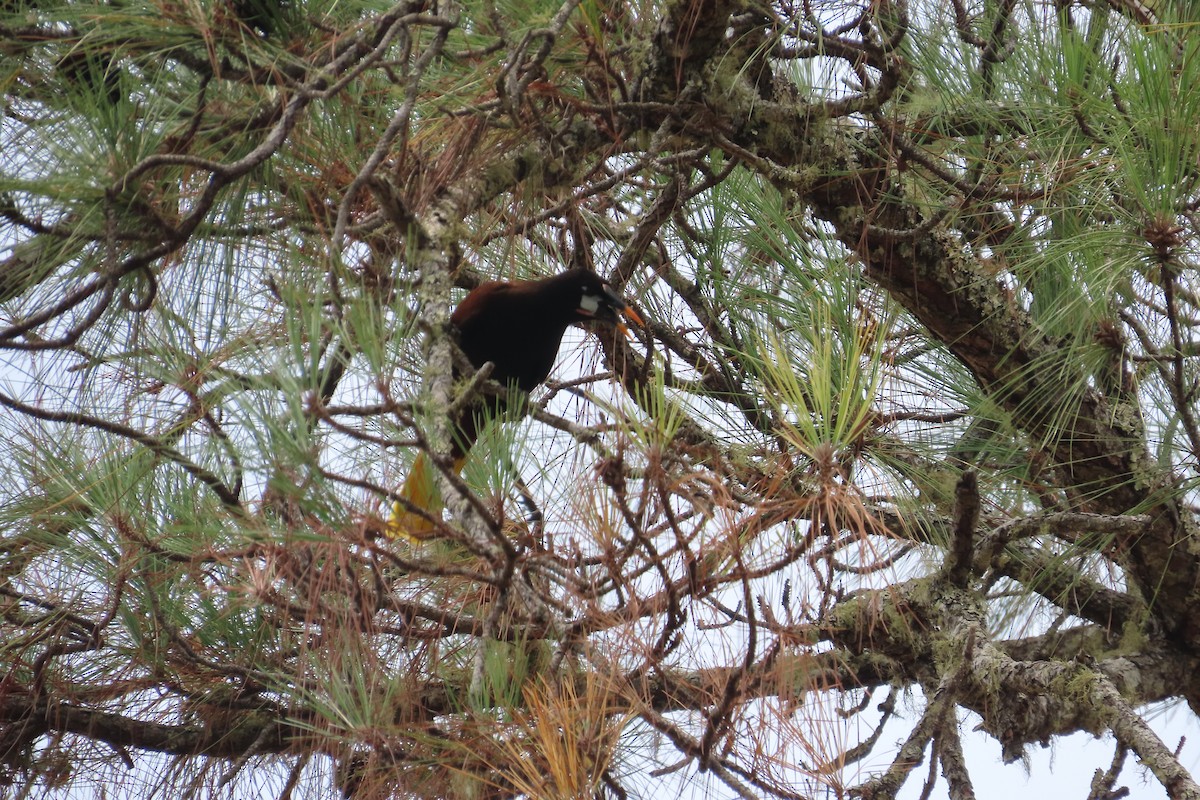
386 267 646 543
